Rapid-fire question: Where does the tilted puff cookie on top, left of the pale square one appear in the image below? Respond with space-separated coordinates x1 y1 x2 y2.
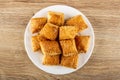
40 23 58 40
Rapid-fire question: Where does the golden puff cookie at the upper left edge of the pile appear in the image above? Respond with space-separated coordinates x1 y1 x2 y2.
31 17 47 33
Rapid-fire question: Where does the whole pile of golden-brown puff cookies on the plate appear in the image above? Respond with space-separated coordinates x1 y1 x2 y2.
31 11 90 69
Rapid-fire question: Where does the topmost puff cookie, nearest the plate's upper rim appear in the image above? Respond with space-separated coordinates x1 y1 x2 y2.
47 11 64 26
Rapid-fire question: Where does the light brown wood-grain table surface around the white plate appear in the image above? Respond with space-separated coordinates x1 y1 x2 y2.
0 0 120 80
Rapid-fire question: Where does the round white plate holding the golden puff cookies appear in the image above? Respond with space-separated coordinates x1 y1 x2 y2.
24 5 94 74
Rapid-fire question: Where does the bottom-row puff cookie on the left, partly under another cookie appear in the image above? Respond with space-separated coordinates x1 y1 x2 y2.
42 55 60 65
